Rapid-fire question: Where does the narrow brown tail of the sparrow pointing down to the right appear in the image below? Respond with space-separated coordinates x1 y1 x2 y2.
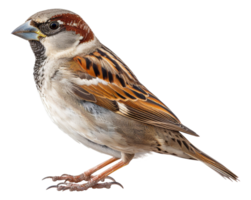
190 149 241 184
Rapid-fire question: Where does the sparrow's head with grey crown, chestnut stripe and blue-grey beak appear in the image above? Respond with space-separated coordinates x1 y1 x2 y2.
10 7 96 58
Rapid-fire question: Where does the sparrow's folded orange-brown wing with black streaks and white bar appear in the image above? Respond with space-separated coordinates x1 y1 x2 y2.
71 47 200 138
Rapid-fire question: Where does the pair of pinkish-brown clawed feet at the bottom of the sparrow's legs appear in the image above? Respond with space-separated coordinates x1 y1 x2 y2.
41 172 125 193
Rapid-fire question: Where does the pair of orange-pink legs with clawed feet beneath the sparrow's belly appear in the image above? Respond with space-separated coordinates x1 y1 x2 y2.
42 158 130 192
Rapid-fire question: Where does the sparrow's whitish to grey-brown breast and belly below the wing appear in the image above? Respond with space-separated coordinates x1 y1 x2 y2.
38 67 157 157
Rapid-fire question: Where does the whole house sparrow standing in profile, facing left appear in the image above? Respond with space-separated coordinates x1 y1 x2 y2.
11 7 241 192
